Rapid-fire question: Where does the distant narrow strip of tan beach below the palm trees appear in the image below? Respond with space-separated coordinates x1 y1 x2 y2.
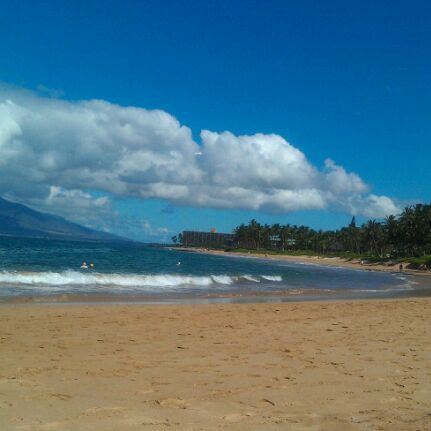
176 247 431 276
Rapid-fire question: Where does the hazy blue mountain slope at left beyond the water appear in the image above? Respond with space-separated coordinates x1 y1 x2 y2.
0 198 129 241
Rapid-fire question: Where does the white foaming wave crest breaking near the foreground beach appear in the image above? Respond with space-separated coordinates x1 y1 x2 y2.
0 270 282 288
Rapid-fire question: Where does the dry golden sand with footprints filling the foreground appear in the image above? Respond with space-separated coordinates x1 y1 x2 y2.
0 299 431 431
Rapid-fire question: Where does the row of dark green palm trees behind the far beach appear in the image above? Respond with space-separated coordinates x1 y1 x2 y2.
234 204 431 258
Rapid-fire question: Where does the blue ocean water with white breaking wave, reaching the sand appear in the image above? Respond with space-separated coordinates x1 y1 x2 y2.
0 237 430 303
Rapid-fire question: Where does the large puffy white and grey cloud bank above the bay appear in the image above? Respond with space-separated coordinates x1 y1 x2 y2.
0 87 398 220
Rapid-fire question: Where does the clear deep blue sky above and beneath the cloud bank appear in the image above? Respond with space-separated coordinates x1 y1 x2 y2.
0 1 431 240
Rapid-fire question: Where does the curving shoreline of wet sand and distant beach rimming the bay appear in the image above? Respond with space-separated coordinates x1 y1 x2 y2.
0 247 431 307
